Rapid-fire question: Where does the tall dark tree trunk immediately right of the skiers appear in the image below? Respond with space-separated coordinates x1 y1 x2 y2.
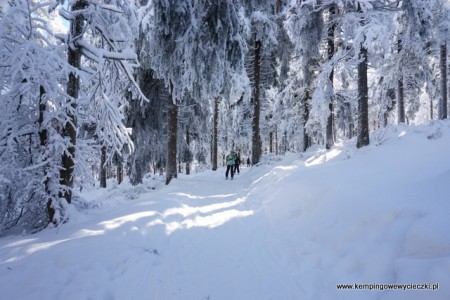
252 40 262 165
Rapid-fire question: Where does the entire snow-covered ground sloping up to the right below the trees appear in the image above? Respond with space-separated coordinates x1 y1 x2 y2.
0 121 450 300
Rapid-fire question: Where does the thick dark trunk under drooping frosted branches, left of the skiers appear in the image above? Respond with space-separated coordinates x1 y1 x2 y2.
166 84 178 185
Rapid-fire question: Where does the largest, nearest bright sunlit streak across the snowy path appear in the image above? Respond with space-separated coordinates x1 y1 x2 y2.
166 209 253 235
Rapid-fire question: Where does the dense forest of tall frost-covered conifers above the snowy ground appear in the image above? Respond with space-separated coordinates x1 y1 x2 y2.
0 0 450 233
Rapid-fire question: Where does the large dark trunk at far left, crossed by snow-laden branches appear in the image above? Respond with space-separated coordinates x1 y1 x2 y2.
60 0 88 203
